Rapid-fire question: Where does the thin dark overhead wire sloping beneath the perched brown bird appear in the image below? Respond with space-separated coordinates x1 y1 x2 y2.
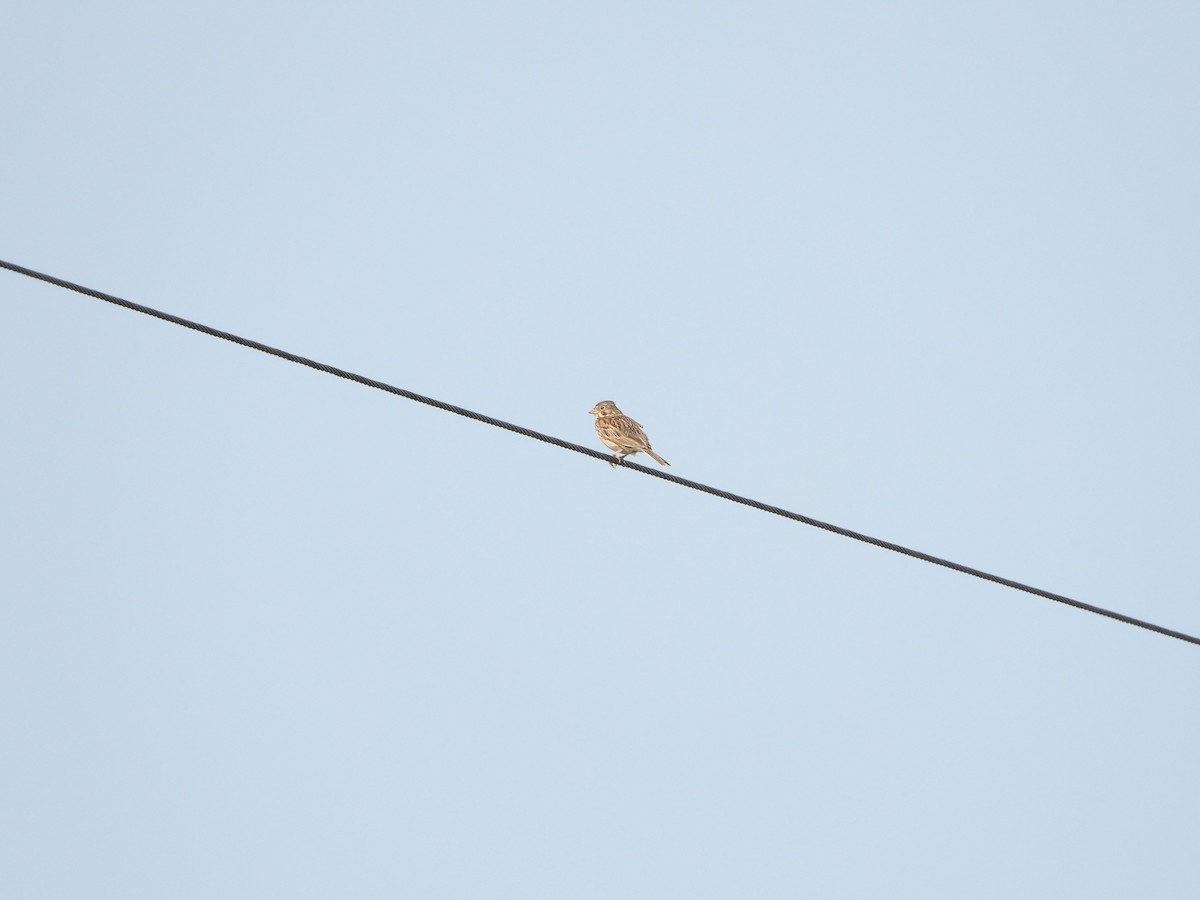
0 259 1200 644
